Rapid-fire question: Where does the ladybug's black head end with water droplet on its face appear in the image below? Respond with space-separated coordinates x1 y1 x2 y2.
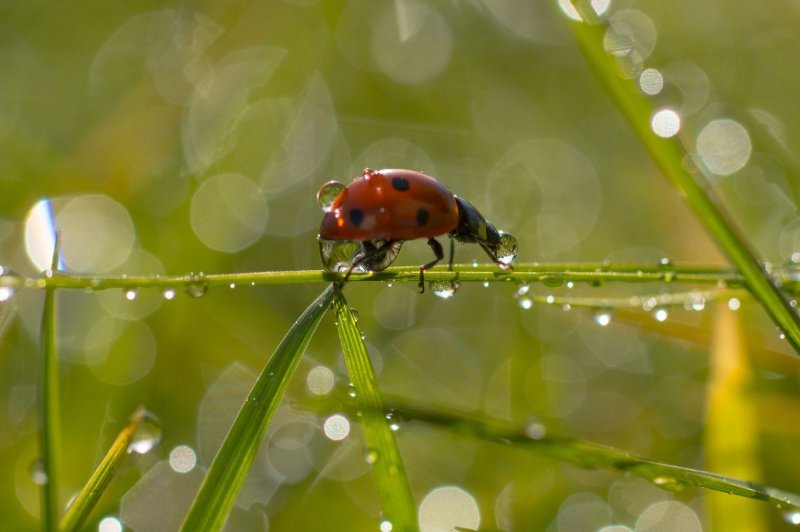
450 196 518 269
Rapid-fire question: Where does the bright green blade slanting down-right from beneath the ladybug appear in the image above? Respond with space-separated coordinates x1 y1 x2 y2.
334 290 418 530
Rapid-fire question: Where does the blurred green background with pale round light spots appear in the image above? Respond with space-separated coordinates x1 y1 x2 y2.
0 0 800 530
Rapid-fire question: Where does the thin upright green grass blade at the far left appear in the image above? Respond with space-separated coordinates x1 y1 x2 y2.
40 244 61 530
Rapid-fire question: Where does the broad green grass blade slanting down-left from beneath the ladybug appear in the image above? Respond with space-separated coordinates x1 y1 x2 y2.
182 285 333 532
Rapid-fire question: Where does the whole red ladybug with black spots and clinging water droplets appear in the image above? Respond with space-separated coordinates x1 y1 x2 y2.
317 168 517 293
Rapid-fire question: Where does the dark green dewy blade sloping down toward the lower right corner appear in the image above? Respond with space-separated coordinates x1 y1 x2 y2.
389 402 800 512
